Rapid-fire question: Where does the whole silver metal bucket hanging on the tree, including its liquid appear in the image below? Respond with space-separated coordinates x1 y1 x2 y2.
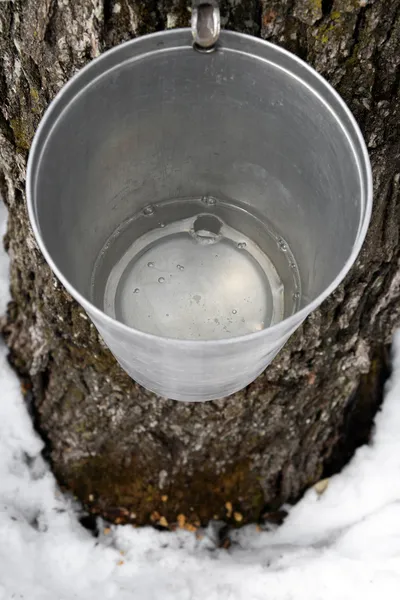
27 12 372 401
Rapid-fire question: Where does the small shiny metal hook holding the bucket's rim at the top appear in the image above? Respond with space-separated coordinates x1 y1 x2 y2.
192 0 221 52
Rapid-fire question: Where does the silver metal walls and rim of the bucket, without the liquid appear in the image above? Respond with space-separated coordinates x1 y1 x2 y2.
27 29 372 401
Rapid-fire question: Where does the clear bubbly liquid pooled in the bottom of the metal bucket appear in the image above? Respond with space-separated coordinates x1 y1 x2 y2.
92 195 301 340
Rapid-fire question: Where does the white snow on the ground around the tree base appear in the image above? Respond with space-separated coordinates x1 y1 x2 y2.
0 199 400 600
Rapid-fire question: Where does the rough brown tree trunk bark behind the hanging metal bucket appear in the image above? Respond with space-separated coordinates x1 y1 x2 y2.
0 0 400 525
